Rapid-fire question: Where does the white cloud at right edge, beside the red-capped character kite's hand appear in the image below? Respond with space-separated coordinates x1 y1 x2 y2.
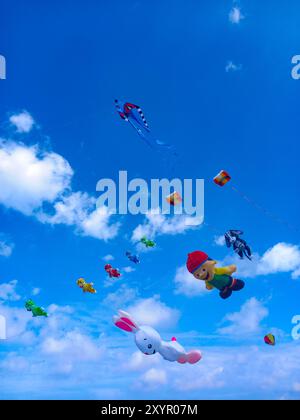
222 242 300 279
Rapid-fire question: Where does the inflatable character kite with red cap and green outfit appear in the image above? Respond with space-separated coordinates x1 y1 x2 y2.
186 251 245 299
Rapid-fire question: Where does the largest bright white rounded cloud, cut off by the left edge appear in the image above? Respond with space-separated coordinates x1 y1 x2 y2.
0 141 73 215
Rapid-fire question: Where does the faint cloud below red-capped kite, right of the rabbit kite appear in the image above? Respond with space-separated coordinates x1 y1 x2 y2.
218 298 269 337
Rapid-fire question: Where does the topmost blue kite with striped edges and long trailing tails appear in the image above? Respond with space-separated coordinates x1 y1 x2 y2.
115 99 176 155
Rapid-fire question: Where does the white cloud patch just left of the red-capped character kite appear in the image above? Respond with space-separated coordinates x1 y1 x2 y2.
174 265 207 297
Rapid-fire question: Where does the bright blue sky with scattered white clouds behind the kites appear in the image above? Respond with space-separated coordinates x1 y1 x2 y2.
0 0 300 399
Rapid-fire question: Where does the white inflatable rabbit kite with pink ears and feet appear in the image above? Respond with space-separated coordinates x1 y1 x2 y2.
113 311 202 364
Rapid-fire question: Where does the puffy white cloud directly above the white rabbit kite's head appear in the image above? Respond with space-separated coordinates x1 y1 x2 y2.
126 295 180 329
